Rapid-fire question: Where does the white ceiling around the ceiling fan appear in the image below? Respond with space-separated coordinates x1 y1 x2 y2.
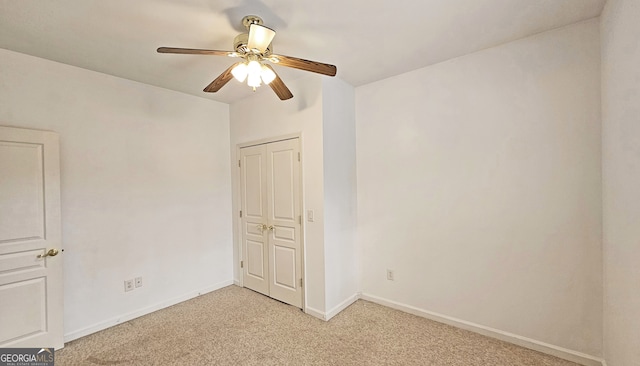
0 0 605 103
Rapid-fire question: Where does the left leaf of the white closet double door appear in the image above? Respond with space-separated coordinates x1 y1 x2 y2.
240 145 269 295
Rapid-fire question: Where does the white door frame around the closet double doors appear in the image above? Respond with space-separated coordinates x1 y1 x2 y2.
233 133 307 311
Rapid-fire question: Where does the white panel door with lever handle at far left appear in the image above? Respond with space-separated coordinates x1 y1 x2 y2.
0 127 64 348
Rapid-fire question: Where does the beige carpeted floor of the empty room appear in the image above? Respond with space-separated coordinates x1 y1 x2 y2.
55 286 576 366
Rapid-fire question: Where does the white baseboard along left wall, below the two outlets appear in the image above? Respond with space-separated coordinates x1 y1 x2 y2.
64 280 233 342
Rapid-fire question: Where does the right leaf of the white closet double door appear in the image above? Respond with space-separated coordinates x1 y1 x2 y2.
266 139 302 308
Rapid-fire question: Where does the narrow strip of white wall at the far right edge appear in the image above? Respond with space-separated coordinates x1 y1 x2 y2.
601 0 640 366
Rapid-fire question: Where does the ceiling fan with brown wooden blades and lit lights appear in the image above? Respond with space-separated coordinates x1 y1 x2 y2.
158 15 337 100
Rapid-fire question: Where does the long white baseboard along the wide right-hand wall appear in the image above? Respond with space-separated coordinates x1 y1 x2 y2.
360 293 606 366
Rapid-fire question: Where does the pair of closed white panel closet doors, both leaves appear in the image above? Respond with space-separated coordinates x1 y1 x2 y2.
240 139 302 308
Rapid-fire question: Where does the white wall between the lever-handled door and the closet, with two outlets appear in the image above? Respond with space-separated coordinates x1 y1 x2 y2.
0 49 233 340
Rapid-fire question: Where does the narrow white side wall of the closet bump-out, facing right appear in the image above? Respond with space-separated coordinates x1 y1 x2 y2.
322 78 360 317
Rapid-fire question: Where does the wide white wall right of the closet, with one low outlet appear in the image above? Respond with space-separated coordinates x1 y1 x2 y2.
356 20 604 357
